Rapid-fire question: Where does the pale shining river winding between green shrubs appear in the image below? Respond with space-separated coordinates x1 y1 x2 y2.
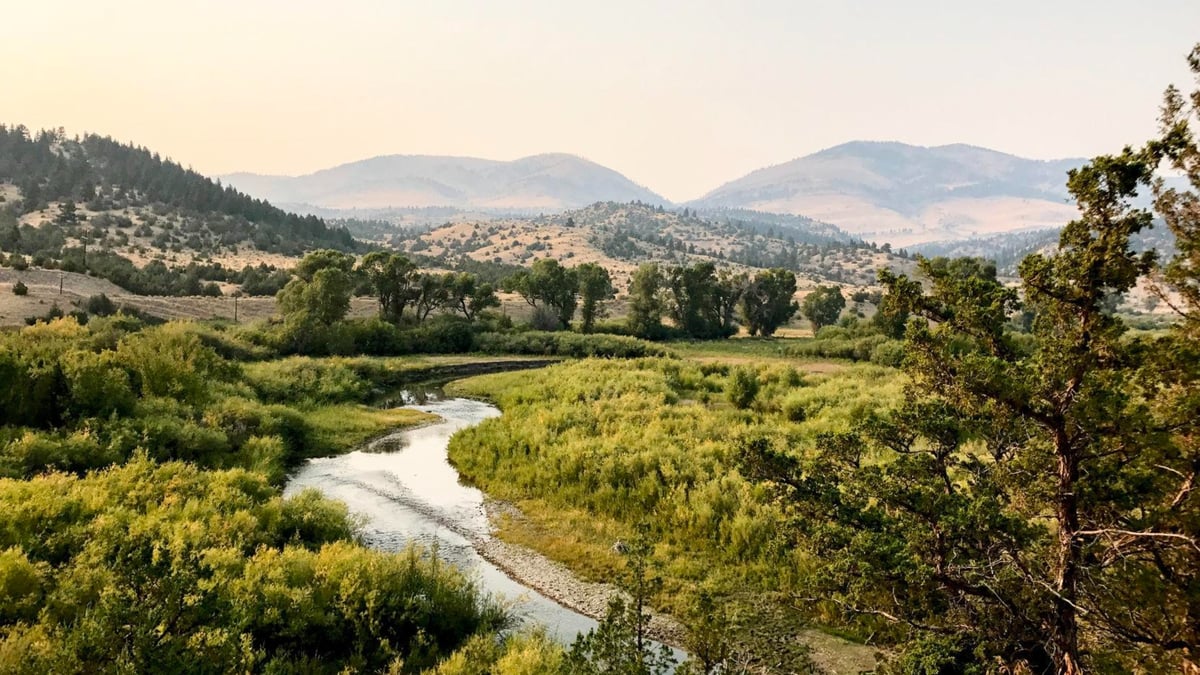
284 395 609 644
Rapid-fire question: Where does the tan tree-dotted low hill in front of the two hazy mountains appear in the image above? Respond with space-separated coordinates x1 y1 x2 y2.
390 202 913 288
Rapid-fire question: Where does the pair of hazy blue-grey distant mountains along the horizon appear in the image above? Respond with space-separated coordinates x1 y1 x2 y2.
221 141 1099 246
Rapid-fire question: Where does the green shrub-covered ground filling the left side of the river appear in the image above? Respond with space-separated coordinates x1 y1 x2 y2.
0 317 576 674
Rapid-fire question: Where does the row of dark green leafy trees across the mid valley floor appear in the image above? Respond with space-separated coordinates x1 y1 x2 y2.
277 250 845 340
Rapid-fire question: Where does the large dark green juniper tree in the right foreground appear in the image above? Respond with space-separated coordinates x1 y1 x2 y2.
743 142 1200 674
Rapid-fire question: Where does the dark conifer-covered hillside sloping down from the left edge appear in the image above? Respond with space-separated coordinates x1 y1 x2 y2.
0 125 360 295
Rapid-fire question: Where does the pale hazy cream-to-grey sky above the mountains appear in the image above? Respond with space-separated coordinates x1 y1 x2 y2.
0 0 1200 201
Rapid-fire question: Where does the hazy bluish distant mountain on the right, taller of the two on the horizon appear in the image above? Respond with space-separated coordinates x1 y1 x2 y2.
689 142 1085 246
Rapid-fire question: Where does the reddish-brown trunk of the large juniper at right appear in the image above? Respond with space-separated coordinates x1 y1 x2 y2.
1051 428 1084 675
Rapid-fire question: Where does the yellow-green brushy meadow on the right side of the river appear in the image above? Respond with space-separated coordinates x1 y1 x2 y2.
450 355 904 668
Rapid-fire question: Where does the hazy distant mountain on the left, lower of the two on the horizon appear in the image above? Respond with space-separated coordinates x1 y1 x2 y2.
221 154 668 213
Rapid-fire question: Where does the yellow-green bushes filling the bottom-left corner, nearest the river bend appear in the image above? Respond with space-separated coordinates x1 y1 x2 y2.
0 459 505 673
